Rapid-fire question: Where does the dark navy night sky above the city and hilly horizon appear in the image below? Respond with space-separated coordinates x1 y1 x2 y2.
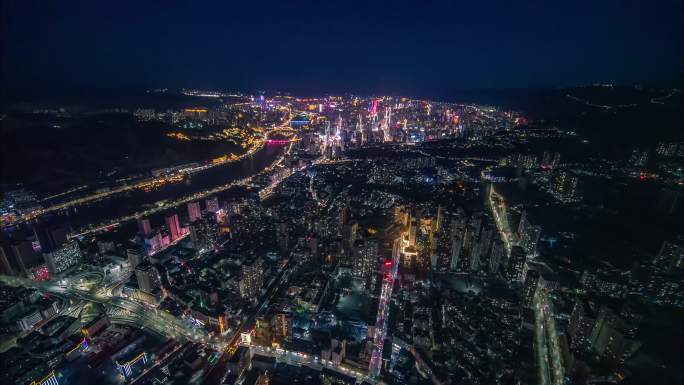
0 0 683 96
